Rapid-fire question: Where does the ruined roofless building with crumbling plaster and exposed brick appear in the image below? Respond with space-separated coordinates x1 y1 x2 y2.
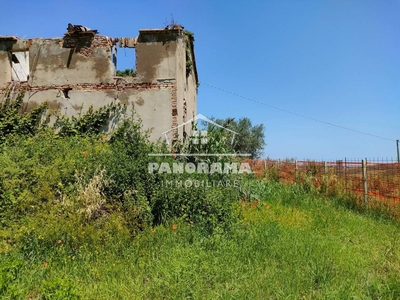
0 24 198 144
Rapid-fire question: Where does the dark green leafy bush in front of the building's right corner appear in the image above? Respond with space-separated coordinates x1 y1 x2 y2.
102 120 239 234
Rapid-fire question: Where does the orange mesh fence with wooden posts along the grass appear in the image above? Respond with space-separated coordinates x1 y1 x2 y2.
250 159 400 218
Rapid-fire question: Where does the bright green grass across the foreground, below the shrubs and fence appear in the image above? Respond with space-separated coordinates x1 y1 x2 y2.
0 182 400 299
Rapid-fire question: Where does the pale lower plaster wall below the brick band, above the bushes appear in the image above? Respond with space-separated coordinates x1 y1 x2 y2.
24 84 175 141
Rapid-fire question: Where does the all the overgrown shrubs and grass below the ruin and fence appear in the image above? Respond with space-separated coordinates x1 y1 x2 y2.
0 92 400 299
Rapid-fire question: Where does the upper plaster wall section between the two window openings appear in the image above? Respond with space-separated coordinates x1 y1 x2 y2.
28 35 115 86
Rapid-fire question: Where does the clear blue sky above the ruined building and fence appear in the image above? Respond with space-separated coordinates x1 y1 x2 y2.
0 0 400 160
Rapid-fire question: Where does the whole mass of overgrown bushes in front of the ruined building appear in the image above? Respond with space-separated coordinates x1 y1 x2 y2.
0 94 244 268
